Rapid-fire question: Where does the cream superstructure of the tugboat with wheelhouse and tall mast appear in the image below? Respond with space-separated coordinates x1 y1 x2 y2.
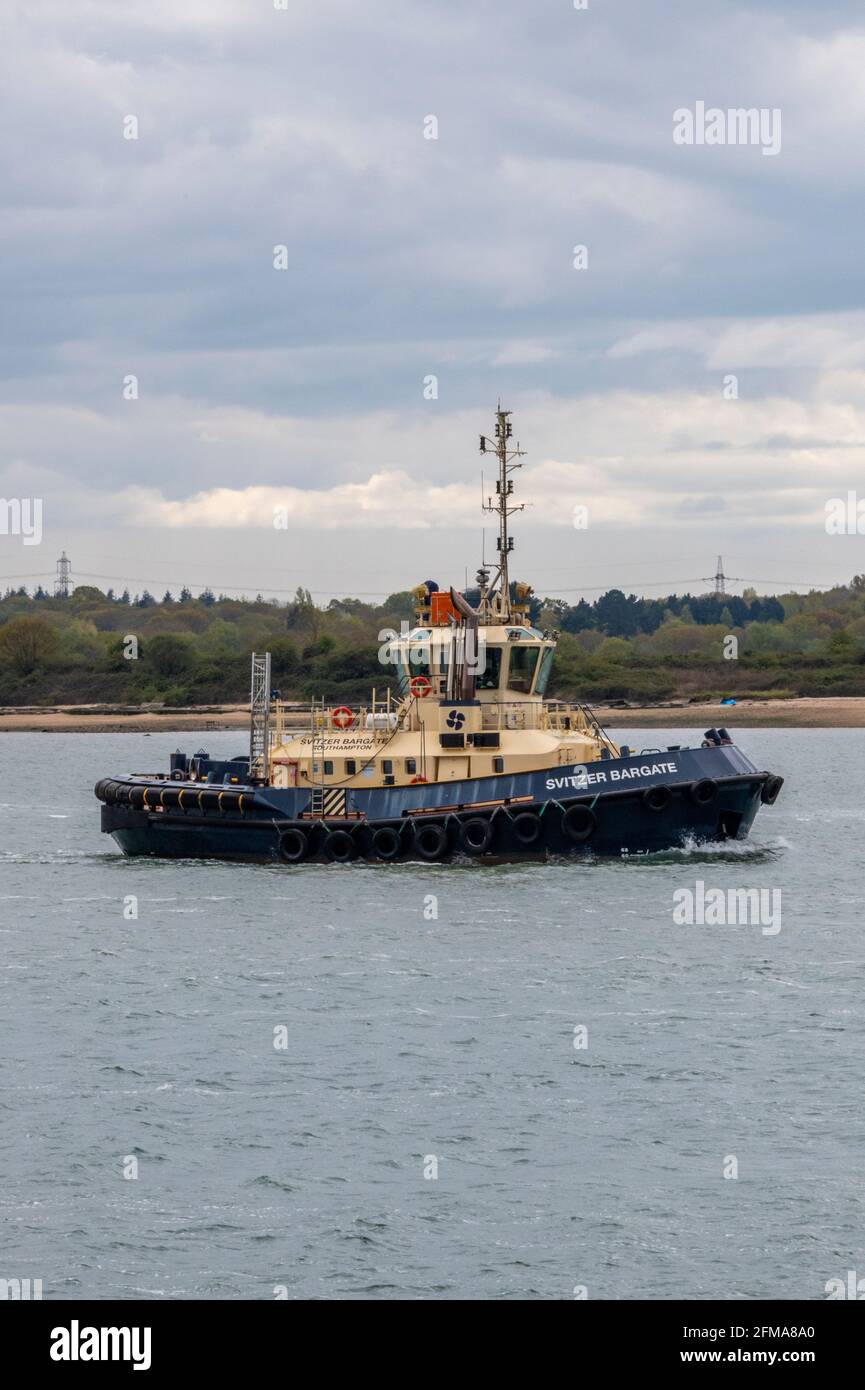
267 407 619 809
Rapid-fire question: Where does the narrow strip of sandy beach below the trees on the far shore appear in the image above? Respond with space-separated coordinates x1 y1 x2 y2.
0 696 865 734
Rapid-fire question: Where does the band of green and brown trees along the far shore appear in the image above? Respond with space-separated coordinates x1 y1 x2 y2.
0 575 865 706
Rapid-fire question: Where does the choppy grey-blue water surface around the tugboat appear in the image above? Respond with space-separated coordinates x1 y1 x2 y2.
0 730 865 1298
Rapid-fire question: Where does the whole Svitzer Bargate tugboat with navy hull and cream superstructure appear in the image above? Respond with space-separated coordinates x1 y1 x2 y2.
96 404 783 865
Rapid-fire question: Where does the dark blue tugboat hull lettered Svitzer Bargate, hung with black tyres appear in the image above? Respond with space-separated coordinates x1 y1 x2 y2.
96 745 782 863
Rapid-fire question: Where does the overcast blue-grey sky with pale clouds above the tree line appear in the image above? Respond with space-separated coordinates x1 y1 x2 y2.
0 0 865 602
